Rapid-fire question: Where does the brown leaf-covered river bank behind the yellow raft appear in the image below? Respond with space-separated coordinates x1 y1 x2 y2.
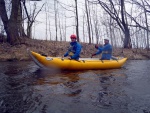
0 39 150 61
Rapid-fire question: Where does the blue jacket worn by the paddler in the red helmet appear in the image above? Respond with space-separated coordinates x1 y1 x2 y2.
64 42 82 60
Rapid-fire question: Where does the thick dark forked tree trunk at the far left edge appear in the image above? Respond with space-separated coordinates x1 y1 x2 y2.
0 0 20 45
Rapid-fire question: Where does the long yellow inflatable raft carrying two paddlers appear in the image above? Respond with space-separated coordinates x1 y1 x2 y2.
29 51 127 70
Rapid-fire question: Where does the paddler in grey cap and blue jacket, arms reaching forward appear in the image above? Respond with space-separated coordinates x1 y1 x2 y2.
91 39 112 60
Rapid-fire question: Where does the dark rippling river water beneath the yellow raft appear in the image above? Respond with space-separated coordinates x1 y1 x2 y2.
0 60 150 113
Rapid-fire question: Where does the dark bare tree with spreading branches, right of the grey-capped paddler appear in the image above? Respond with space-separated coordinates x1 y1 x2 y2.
98 0 131 48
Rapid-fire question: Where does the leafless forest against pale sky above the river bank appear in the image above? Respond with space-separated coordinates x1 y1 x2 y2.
0 0 150 50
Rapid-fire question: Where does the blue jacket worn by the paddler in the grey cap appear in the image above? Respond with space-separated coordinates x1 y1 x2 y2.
95 44 112 60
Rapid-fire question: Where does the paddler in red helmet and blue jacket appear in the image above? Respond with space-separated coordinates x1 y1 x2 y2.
64 34 82 60
